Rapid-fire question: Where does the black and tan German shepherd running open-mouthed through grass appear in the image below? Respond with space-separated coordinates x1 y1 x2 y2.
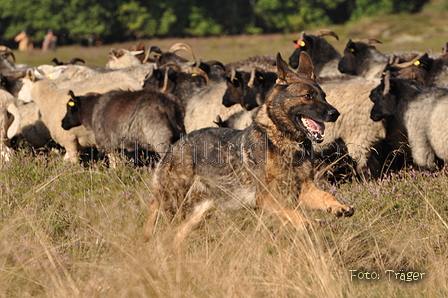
144 52 354 246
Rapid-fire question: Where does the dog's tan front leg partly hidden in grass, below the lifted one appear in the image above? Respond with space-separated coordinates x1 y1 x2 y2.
257 192 311 230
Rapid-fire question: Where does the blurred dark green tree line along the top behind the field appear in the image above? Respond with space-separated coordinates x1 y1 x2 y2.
0 0 429 45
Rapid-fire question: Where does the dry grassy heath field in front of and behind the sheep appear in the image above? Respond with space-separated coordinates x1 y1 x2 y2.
0 1 448 297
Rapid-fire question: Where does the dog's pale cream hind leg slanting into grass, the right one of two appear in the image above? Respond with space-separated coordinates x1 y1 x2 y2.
173 199 214 252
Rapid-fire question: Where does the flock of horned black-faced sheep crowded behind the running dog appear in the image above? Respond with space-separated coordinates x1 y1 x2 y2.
0 30 448 178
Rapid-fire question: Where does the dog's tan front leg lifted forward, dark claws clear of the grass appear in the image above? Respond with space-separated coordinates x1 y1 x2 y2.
299 180 355 217
